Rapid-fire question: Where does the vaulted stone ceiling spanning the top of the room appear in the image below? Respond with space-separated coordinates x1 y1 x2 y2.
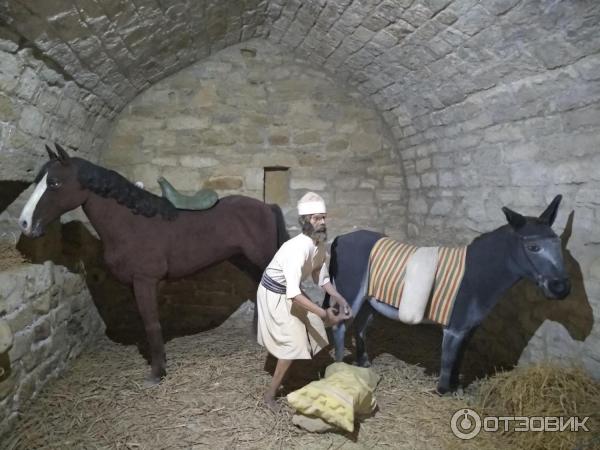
1 0 600 138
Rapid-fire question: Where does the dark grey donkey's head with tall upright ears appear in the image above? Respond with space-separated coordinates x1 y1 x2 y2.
502 195 571 299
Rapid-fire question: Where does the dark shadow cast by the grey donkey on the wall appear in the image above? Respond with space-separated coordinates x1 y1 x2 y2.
347 212 594 384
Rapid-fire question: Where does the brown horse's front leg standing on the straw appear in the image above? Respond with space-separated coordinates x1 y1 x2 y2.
133 278 167 384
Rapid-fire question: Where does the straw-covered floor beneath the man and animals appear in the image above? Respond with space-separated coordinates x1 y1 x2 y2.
0 310 600 449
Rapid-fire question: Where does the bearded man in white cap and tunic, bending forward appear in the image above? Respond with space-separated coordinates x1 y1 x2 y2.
256 192 351 410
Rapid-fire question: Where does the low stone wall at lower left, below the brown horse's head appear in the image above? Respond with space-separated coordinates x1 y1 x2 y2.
0 262 104 439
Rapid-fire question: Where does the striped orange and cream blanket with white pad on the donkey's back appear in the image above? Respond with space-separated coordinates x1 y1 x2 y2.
367 237 467 325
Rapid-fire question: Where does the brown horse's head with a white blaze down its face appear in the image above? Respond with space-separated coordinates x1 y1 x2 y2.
19 144 88 237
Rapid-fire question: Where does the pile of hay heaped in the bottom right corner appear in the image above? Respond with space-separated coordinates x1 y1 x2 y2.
475 363 600 450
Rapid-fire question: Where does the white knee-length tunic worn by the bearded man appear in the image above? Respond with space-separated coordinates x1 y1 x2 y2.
256 233 329 359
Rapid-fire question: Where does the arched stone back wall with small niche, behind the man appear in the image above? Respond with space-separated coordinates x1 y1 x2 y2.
101 40 405 237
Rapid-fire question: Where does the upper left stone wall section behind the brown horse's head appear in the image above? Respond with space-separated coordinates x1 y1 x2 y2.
0 23 114 237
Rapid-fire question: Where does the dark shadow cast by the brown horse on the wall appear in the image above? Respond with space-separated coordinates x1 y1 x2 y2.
17 221 256 354
